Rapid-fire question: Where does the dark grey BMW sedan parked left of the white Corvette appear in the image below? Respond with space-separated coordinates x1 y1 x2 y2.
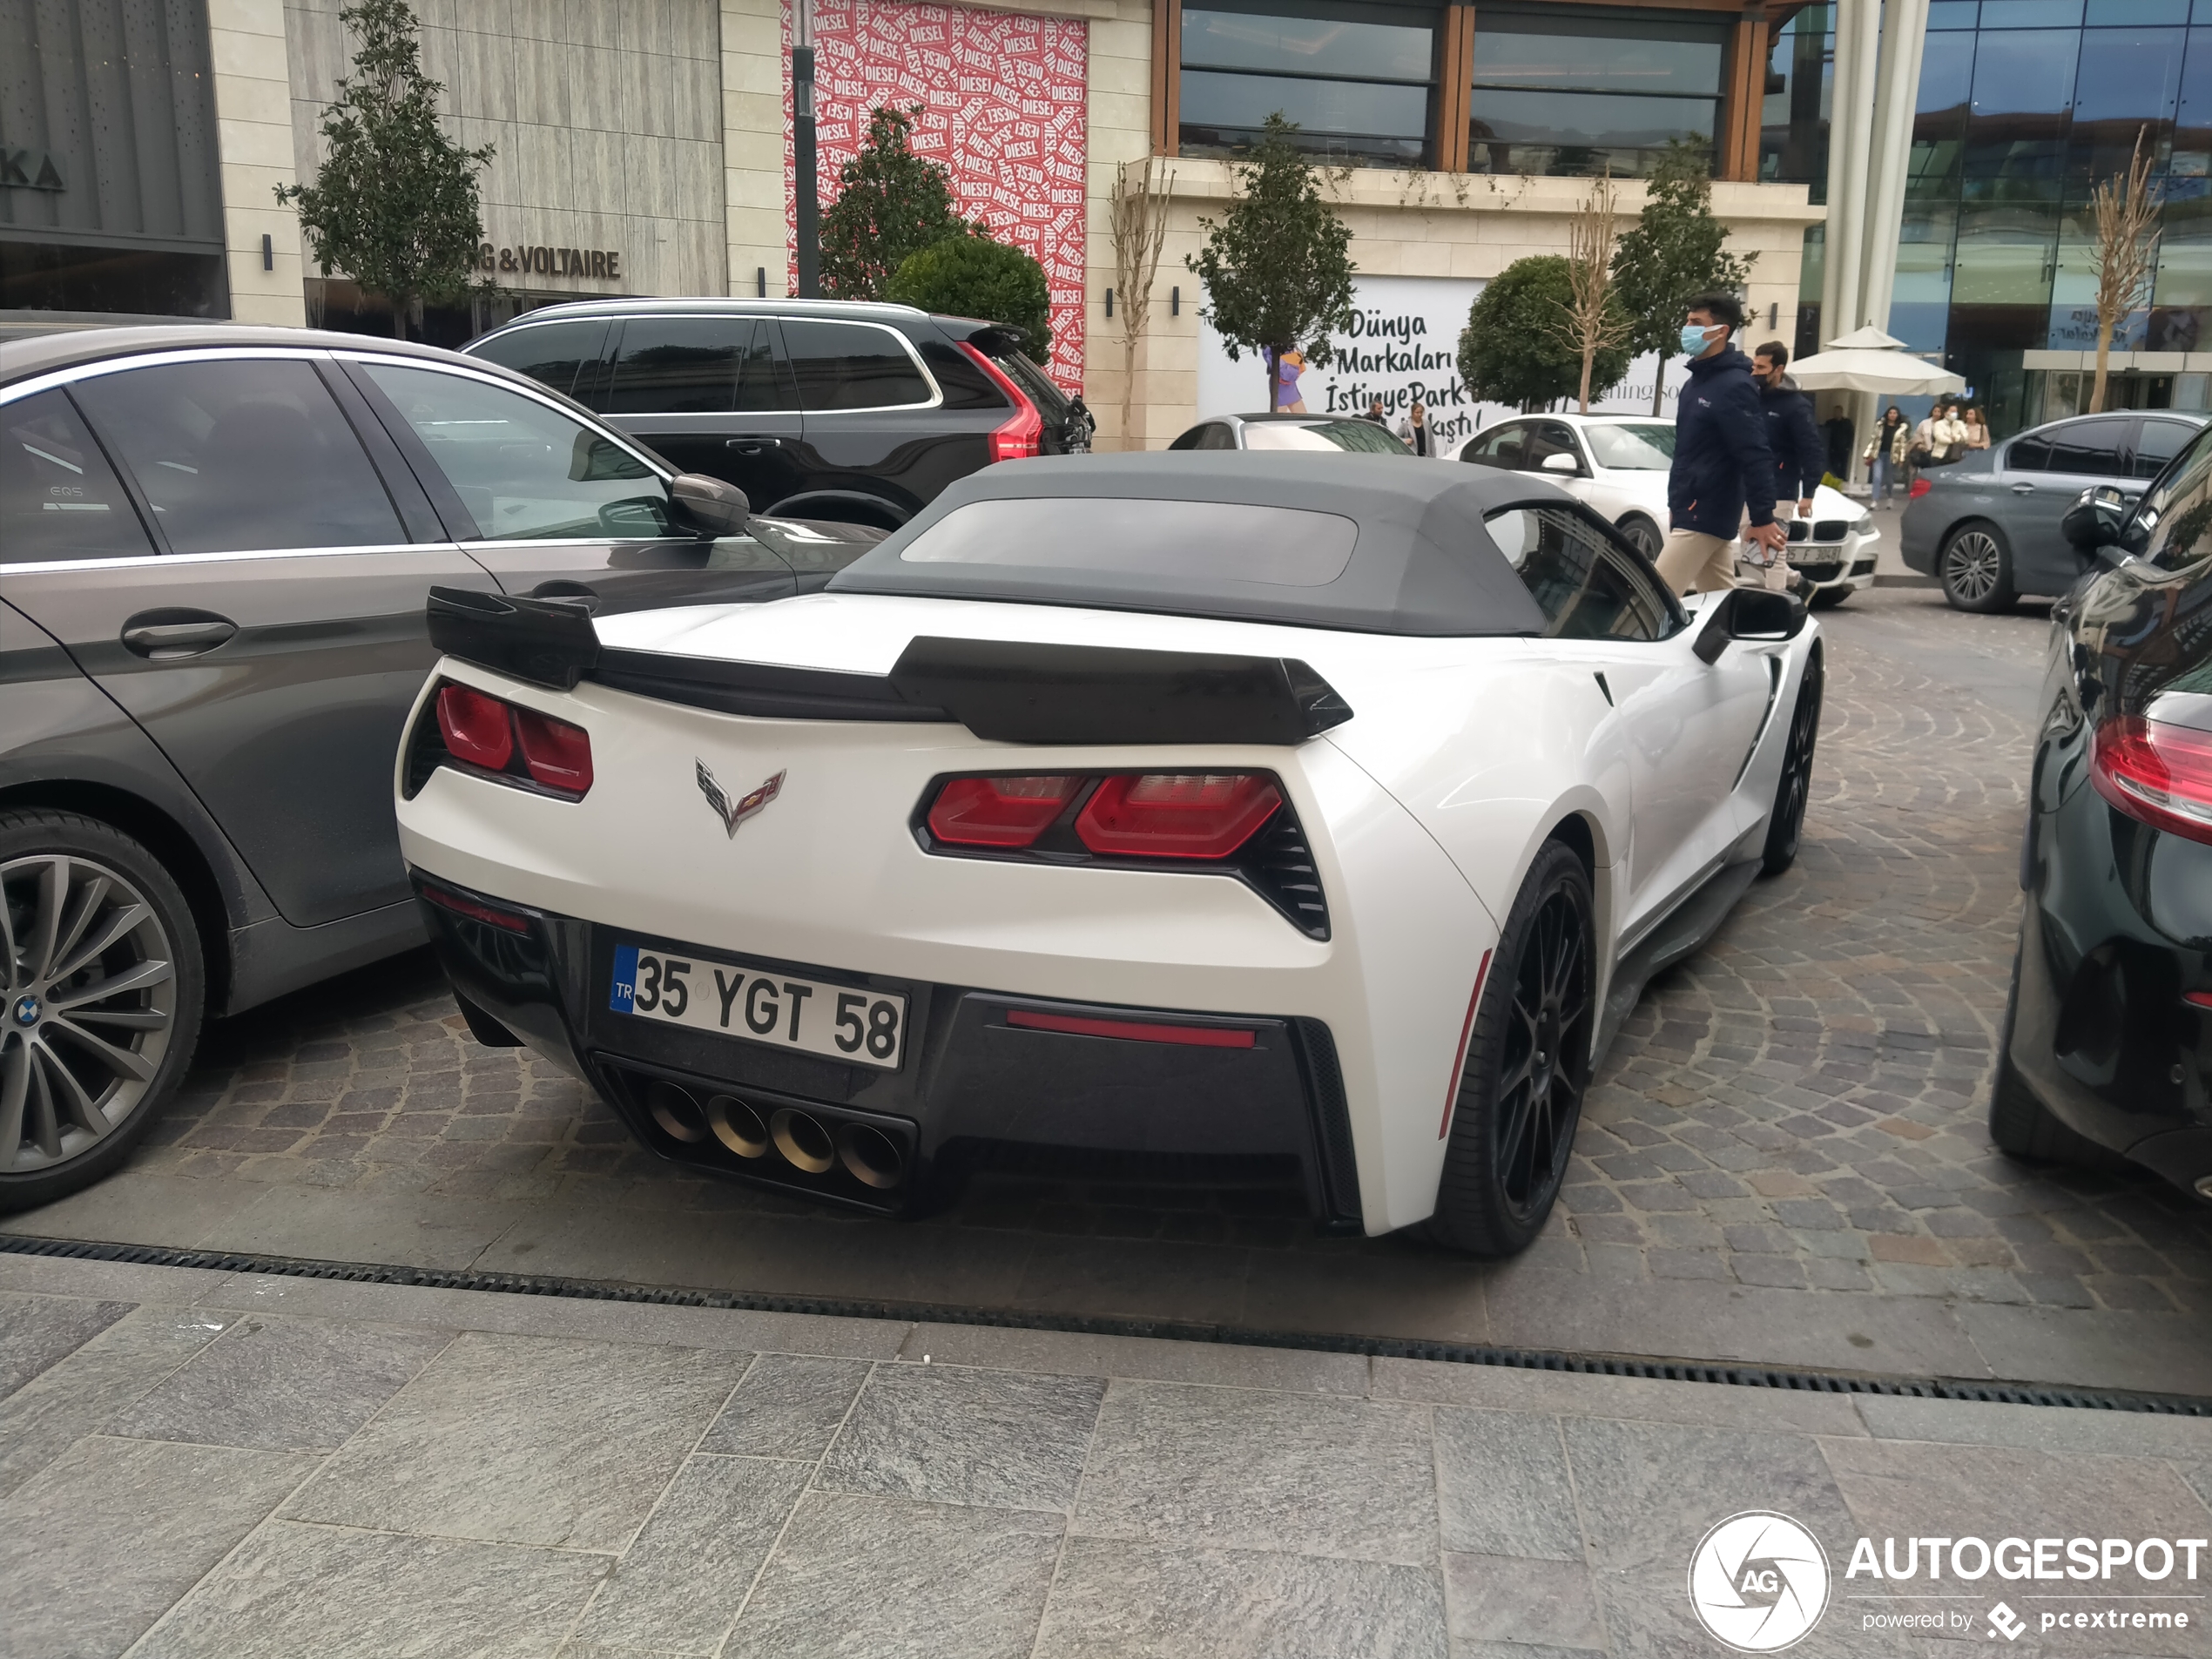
0 325 880 1208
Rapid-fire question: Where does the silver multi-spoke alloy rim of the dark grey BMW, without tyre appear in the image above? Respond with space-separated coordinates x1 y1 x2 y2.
0 853 177 1175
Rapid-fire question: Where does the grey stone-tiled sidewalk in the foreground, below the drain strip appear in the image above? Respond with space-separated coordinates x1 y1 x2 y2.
0 1257 2212 1659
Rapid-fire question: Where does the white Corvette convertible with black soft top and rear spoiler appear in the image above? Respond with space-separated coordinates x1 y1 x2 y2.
398 454 1820 1254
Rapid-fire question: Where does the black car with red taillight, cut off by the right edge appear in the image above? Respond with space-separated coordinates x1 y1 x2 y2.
1988 431 2212 1197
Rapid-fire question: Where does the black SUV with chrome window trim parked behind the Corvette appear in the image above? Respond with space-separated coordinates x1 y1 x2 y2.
464 299 1090 529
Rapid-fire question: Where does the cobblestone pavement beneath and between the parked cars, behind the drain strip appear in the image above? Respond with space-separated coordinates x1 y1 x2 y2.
9 590 2212 1392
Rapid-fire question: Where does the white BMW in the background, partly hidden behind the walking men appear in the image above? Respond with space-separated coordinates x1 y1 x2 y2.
1460 414 1883 609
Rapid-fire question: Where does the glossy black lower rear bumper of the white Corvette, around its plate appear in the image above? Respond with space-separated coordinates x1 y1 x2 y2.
414 872 1360 1230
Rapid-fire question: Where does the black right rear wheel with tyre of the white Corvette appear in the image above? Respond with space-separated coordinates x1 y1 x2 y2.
1429 840 1595 1257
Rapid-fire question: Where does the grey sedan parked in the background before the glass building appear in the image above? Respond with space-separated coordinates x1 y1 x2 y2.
1898 409 2205 610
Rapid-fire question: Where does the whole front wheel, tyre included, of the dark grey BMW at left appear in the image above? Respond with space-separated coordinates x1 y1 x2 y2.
0 812 206 1212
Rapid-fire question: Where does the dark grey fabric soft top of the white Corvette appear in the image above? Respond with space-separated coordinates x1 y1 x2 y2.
830 451 1570 635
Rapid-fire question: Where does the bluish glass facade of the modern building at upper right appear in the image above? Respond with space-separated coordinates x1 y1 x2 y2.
1761 0 2212 434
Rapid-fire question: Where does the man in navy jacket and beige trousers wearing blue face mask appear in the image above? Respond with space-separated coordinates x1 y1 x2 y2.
1659 294 1790 593
